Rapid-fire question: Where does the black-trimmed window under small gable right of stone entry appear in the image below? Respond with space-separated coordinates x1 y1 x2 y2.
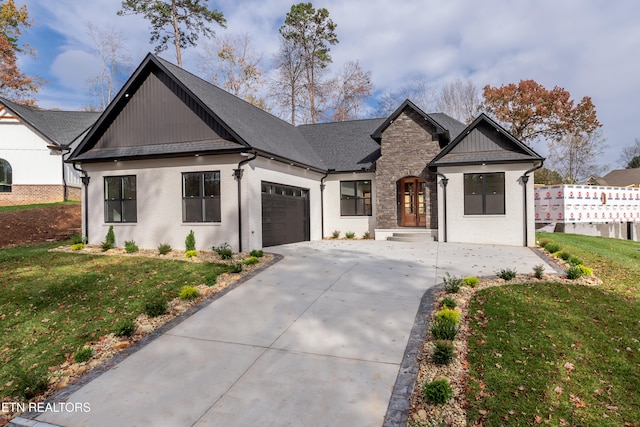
464 172 505 215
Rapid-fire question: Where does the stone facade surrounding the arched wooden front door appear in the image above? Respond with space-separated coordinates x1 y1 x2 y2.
376 109 440 229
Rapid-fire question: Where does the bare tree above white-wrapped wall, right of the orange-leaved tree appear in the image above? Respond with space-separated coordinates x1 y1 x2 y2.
549 131 607 184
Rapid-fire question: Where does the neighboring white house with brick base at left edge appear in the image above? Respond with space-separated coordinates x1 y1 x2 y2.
0 98 99 205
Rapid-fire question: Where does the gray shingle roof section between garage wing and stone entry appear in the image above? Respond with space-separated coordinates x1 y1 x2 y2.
298 119 385 172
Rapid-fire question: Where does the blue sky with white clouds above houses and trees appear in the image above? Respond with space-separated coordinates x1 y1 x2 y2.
16 0 640 168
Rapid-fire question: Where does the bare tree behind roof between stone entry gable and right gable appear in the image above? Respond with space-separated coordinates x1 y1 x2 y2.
436 78 481 124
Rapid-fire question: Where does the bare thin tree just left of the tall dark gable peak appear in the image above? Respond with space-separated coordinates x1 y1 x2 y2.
85 22 133 111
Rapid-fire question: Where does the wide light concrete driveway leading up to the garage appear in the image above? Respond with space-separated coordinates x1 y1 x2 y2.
14 241 552 427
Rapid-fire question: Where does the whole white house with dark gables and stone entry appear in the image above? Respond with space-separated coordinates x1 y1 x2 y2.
69 54 543 251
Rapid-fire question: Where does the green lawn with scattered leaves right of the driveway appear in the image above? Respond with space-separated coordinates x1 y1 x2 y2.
467 234 640 426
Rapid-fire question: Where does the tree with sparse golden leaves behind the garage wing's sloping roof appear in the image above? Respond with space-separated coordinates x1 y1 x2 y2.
198 34 265 108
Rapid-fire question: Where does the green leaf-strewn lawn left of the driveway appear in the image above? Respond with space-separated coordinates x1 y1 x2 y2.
0 242 229 400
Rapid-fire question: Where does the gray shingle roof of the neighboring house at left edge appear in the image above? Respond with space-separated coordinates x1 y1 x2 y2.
0 98 100 146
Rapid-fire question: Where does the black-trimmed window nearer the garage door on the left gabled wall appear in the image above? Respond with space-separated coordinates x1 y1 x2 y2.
182 171 222 222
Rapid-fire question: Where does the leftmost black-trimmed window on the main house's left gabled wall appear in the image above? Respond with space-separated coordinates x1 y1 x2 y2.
104 175 138 222
